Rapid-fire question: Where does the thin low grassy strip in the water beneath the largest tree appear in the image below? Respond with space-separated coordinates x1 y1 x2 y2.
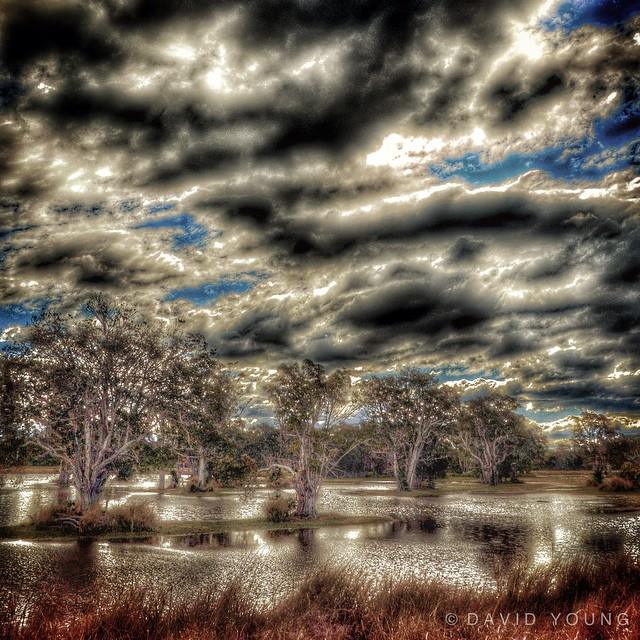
0 513 391 541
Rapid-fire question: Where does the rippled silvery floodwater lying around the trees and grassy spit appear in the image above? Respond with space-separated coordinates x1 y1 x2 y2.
0 475 640 602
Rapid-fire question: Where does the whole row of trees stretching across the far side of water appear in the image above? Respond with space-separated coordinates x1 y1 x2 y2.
0 296 637 517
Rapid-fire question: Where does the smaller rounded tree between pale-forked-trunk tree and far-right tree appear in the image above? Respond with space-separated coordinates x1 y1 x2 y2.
451 394 524 485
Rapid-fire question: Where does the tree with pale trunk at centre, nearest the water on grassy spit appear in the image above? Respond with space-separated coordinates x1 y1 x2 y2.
267 360 354 518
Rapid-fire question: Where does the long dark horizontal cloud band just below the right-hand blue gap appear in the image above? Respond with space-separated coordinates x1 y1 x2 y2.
219 187 629 262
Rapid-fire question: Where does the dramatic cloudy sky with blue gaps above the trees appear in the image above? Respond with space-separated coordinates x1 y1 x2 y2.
0 0 640 424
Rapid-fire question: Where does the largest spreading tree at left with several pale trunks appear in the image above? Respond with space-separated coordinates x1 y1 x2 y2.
13 295 202 511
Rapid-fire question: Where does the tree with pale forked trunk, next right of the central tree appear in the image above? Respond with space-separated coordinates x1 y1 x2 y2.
358 369 459 491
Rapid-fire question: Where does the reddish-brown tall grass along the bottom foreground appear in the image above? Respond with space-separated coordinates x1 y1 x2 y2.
0 559 640 640
